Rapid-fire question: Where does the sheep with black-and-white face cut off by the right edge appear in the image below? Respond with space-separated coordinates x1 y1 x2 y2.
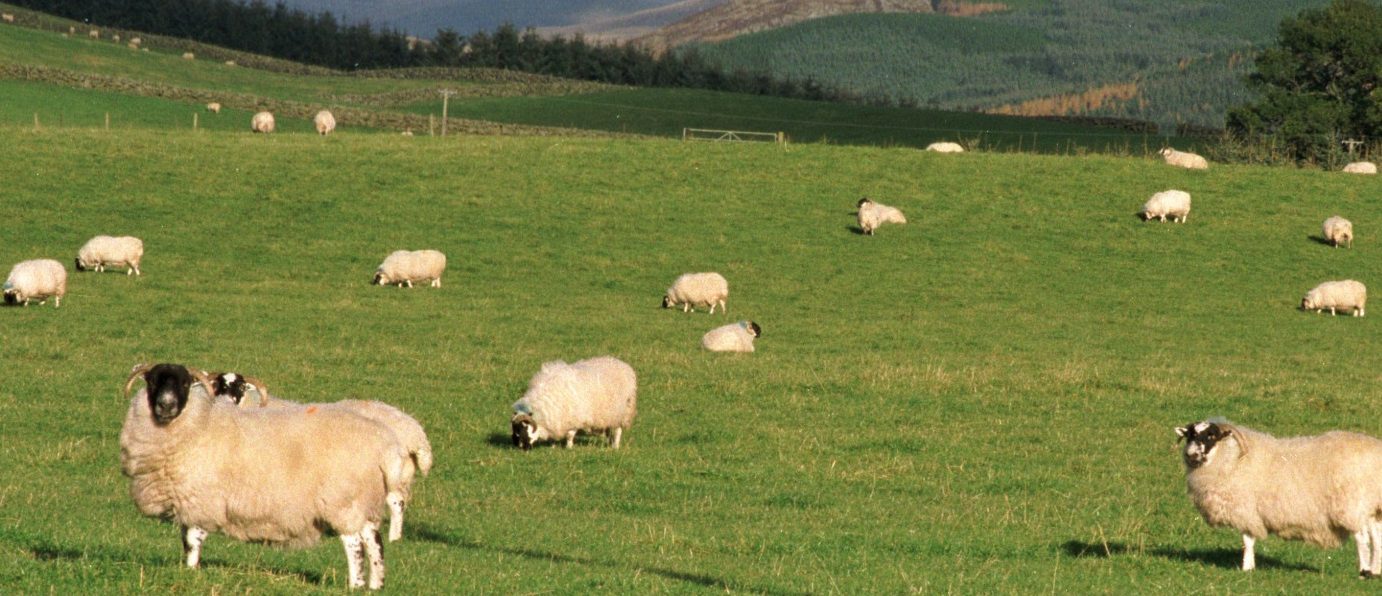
1176 419 1382 578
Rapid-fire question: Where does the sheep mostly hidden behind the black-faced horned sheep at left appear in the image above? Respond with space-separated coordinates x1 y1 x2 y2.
205 372 433 542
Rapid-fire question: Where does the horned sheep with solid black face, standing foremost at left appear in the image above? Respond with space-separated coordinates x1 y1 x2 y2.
120 364 406 589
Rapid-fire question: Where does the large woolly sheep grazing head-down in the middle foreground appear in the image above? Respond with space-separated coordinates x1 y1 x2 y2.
509 355 638 451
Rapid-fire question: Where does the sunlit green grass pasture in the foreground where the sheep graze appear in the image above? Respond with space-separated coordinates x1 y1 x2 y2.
0 127 1382 593
